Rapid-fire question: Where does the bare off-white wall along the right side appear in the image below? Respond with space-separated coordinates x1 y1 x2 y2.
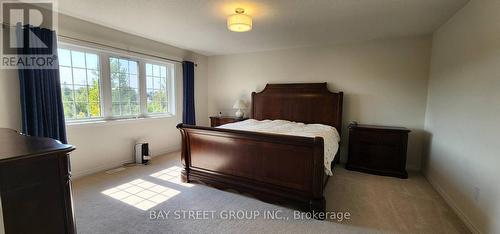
425 0 500 233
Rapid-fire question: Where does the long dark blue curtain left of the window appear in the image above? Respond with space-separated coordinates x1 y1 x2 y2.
17 25 67 144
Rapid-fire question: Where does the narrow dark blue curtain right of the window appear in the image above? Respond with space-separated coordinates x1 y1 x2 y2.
182 61 196 125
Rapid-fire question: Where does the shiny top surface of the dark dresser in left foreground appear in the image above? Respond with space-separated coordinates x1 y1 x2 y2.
0 128 75 163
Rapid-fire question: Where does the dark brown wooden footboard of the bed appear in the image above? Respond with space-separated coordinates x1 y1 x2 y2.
177 124 326 212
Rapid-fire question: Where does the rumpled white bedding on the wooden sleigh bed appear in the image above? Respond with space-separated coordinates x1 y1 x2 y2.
219 119 340 175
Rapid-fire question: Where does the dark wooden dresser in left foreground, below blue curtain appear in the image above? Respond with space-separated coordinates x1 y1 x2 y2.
0 128 76 234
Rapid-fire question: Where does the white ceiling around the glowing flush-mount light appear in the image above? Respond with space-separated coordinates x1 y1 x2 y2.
58 0 468 55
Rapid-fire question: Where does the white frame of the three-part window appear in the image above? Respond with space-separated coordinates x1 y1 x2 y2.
58 41 179 125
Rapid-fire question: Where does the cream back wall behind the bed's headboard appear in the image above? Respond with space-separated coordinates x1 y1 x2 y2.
208 36 431 169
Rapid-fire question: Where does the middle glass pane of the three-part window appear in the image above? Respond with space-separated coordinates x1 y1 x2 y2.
109 57 139 116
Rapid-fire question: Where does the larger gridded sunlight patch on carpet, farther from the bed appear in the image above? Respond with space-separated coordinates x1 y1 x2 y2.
101 179 180 210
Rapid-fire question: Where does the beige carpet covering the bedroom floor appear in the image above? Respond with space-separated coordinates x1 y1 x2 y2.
73 153 469 233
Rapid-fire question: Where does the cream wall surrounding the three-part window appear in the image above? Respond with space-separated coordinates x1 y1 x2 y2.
0 15 208 176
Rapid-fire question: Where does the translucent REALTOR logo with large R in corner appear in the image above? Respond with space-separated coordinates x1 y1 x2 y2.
1 1 57 69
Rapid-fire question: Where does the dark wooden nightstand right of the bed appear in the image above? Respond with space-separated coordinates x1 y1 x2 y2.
346 124 410 179
